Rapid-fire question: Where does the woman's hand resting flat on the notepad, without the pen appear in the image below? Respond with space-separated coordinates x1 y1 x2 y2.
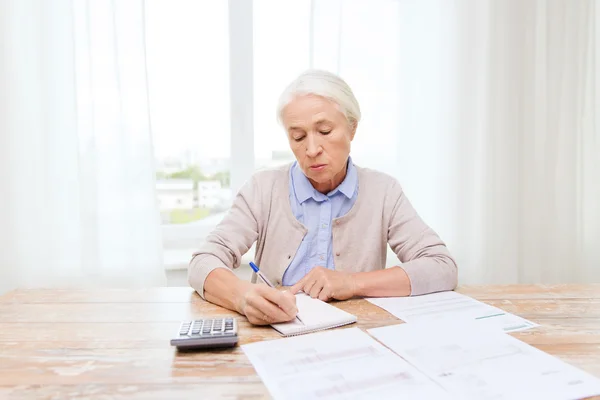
290 267 356 301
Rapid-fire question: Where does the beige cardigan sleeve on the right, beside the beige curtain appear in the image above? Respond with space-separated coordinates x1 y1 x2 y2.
388 182 458 296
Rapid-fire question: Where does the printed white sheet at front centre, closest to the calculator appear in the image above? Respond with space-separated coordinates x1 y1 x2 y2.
242 328 450 400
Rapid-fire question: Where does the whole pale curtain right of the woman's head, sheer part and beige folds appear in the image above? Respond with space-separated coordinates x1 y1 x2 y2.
311 0 600 283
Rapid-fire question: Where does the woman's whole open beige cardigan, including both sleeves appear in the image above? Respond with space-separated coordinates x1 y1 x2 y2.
188 164 457 297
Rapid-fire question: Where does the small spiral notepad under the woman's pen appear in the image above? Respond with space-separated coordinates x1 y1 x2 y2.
271 293 356 336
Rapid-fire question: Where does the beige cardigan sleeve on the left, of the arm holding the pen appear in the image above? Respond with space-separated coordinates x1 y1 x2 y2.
188 177 260 298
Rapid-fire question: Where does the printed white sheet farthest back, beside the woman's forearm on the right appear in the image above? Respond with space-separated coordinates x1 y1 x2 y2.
366 292 539 332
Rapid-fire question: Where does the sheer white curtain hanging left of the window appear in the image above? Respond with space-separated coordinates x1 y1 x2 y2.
0 0 165 292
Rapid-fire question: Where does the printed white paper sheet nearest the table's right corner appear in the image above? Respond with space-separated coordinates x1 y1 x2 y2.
368 322 600 400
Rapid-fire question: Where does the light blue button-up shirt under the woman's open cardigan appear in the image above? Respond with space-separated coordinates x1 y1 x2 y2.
282 158 358 286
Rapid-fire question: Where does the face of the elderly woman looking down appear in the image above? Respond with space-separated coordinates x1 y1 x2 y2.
282 95 356 193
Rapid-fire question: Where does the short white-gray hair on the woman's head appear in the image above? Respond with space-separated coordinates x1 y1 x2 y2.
277 69 360 127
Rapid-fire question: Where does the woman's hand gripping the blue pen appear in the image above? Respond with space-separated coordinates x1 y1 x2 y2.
237 284 298 325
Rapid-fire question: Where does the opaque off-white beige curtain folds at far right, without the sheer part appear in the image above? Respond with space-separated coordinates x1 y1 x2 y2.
447 0 600 283
